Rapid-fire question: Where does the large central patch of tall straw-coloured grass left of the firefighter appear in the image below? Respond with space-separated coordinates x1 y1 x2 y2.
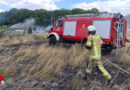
2 45 88 79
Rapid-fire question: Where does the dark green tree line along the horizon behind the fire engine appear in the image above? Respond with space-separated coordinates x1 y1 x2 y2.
0 8 100 26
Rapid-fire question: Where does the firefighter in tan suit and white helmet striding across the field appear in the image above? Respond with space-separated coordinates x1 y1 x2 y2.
85 25 112 80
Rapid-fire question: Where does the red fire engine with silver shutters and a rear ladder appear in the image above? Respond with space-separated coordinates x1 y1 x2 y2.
48 13 127 48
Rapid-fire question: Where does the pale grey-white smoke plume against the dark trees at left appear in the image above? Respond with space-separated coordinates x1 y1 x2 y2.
10 18 35 30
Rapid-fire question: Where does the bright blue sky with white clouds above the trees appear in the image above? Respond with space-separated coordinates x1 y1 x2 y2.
0 0 130 15
